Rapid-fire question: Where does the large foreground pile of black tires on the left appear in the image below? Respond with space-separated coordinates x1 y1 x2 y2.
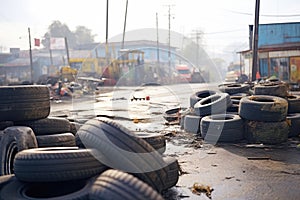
0 85 179 200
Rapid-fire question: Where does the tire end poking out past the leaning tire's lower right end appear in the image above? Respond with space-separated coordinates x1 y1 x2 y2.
164 157 180 190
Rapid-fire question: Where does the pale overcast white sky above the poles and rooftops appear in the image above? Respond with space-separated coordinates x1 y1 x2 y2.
0 0 300 61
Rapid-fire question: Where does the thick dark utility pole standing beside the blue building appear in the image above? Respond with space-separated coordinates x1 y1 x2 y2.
252 0 260 81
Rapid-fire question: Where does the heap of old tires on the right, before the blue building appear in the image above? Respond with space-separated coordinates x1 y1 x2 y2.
165 80 300 144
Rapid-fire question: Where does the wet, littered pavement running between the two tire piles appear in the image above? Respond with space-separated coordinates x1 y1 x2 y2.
50 84 300 200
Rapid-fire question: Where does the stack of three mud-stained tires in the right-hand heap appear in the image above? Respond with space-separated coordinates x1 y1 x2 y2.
239 81 290 144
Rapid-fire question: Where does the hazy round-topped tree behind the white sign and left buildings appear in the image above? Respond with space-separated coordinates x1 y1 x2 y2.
42 21 95 48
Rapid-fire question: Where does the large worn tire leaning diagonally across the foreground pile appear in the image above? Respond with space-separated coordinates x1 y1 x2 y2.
77 118 166 192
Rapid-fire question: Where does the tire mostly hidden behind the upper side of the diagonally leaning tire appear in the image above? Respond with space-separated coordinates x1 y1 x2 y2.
135 133 166 154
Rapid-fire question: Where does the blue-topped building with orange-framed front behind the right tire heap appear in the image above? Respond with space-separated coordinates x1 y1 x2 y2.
240 22 300 83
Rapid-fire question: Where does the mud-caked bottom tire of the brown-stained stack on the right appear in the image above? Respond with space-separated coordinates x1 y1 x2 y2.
245 121 289 144
